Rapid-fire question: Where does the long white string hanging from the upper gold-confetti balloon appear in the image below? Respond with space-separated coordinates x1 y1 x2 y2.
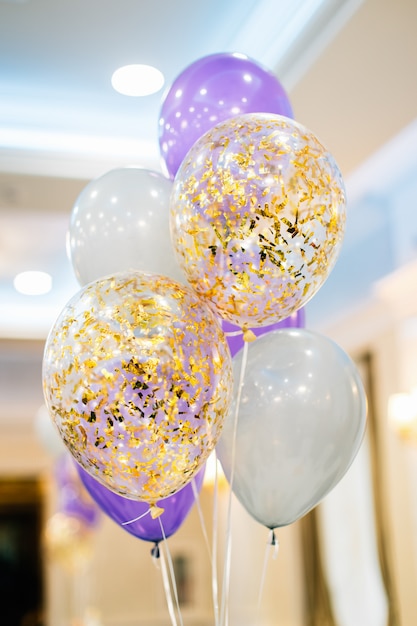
220 341 249 626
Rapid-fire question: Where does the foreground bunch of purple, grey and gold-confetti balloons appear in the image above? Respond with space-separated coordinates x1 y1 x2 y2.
43 54 366 608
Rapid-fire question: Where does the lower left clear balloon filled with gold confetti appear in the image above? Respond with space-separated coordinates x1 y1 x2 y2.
42 271 232 504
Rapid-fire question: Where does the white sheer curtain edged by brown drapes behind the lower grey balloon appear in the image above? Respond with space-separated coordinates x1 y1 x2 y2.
300 354 400 626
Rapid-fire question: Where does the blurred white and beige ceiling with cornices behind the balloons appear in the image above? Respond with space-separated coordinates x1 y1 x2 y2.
0 0 417 346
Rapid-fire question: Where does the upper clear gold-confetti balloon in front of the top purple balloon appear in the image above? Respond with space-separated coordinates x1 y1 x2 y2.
171 113 346 328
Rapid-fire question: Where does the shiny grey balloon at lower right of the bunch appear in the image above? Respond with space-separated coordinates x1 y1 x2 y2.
216 329 366 529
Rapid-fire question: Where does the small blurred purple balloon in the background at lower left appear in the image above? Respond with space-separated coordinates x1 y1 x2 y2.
54 454 99 528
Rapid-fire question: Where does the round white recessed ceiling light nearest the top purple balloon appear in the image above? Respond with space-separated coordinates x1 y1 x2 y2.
111 65 164 96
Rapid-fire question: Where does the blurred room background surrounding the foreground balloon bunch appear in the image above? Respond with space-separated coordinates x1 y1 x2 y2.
0 0 417 626
